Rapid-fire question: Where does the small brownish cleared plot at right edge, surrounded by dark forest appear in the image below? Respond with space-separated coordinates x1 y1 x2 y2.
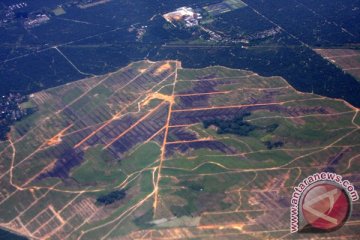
315 49 360 81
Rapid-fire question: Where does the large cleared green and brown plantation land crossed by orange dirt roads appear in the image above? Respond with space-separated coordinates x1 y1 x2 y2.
0 61 360 240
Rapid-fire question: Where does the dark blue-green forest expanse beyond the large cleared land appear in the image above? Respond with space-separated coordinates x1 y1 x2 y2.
0 0 360 106
